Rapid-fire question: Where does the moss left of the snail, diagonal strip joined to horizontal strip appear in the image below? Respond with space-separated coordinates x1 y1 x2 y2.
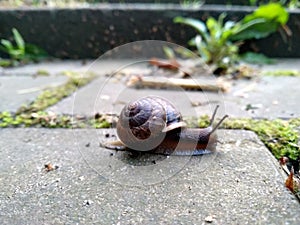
0 71 97 128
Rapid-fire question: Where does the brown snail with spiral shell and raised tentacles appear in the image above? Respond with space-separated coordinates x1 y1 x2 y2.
102 96 228 155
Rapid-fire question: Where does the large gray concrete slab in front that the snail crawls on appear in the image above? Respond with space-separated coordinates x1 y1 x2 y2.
0 129 300 224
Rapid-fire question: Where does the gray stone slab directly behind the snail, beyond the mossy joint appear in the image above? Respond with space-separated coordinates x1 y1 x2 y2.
48 59 300 119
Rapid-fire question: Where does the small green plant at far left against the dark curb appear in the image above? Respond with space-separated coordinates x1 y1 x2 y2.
0 28 47 62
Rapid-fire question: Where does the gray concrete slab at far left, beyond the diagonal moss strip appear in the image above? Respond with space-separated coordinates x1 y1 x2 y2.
0 75 68 112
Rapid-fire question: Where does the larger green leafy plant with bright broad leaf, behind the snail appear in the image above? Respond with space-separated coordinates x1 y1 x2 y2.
174 3 289 73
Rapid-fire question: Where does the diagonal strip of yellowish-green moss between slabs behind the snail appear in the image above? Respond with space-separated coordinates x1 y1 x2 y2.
17 72 95 114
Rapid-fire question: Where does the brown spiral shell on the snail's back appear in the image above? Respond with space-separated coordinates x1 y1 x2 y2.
117 96 185 151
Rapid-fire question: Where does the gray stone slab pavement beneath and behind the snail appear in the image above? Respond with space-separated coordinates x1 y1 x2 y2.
0 59 300 224
